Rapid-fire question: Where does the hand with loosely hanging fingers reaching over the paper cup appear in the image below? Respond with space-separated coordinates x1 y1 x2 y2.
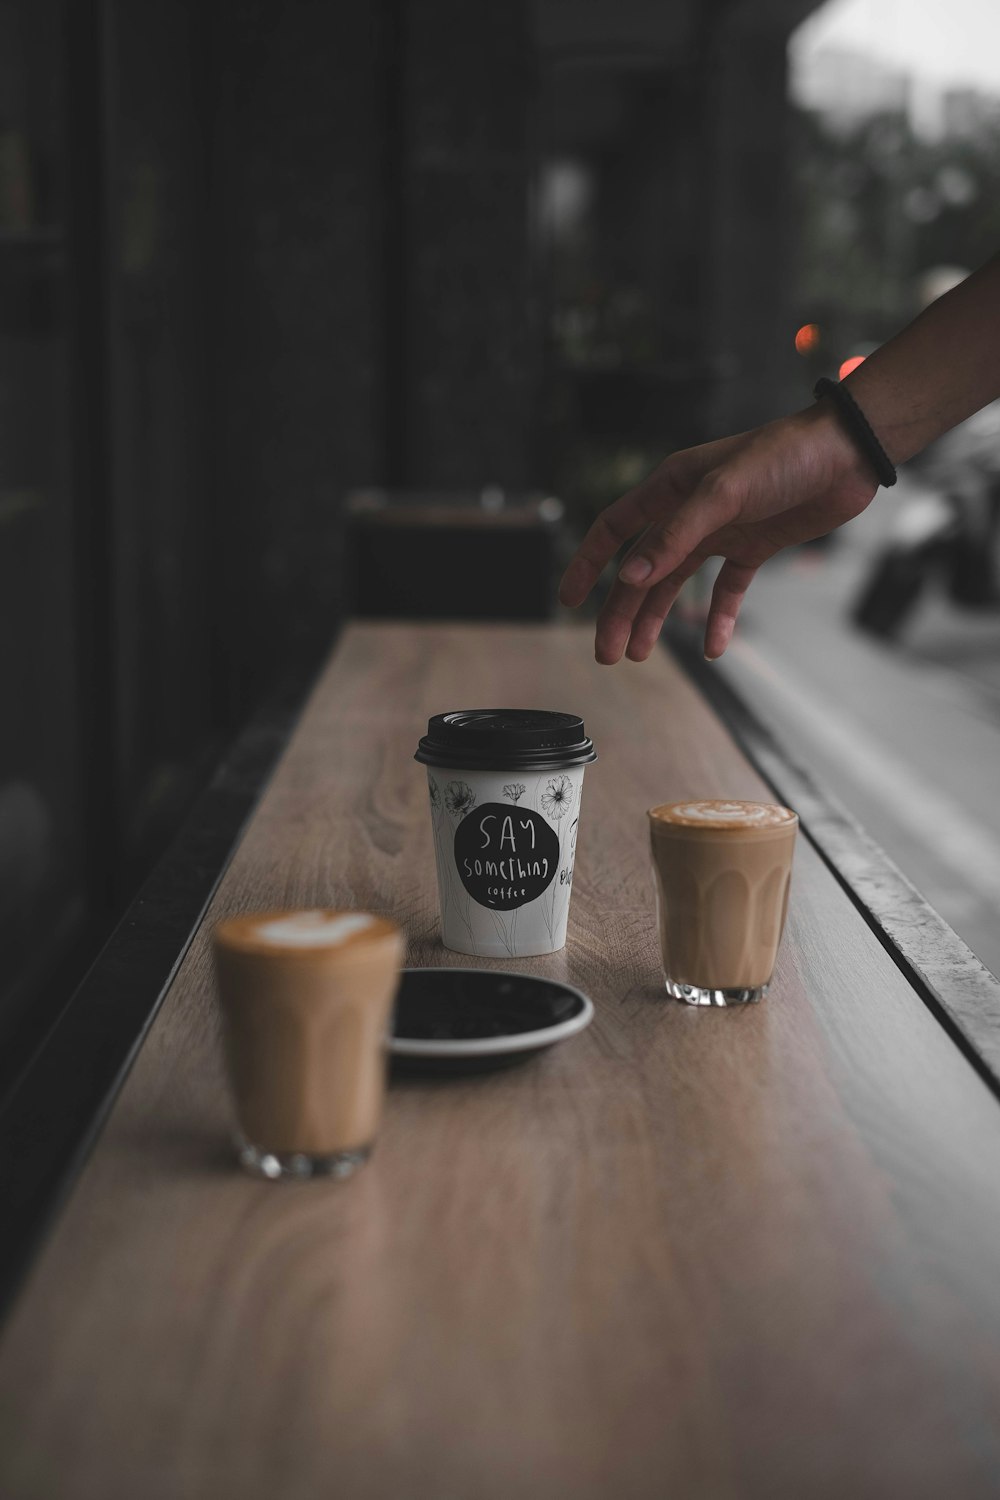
559 402 877 666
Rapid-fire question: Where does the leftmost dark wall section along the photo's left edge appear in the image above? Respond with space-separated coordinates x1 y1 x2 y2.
0 0 81 1068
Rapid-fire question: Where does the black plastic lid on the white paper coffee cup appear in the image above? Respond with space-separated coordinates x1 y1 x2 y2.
414 708 597 771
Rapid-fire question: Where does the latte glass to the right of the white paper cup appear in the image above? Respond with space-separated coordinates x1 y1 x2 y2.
648 800 799 1005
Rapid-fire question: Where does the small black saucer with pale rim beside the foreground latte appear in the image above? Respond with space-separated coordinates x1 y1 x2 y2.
388 969 594 1073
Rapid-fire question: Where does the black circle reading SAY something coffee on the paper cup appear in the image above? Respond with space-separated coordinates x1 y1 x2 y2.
454 803 559 912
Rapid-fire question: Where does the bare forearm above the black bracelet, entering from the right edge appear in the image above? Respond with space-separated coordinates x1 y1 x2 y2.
844 255 1000 464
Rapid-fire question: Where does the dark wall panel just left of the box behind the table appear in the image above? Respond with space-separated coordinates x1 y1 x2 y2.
211 0 388 704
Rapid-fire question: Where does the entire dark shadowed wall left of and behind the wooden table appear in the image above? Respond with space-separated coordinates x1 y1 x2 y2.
0 0 548 1088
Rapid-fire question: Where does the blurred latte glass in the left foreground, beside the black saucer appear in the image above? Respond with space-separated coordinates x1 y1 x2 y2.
214 909 403 1178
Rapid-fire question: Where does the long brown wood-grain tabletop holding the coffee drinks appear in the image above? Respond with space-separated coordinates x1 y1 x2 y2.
0 626 1000 1500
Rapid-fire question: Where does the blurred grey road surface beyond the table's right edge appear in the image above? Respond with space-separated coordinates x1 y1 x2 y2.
715 492 1000 975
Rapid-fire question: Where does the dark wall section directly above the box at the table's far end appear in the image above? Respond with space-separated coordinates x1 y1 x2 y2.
396 0 540 488
